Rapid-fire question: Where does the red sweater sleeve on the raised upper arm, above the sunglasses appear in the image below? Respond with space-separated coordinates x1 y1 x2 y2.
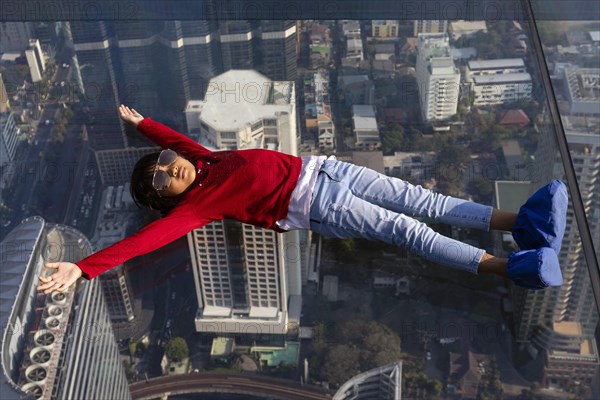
137 118 211 155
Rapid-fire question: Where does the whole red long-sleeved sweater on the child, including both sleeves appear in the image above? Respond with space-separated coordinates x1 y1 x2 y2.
77 118 302 279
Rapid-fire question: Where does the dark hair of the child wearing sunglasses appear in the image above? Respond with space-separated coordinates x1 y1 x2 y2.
130 151 185 216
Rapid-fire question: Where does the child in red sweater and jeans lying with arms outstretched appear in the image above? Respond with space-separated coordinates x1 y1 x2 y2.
38 105 567 293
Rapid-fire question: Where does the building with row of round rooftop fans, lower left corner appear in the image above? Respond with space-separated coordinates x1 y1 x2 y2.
0 217 131 400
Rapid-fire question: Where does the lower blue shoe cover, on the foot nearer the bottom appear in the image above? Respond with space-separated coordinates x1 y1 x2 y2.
506 247 563 290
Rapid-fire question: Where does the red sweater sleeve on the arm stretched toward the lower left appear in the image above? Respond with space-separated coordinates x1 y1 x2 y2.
76 204 211 279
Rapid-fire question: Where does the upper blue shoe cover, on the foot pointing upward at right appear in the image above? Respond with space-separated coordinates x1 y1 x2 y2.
512 180 569 254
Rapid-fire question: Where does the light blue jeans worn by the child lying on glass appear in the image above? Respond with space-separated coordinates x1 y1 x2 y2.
310 159 492 273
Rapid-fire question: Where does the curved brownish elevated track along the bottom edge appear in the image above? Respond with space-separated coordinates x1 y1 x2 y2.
129 373 331 400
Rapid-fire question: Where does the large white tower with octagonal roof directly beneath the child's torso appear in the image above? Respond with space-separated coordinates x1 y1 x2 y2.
185 70 303 335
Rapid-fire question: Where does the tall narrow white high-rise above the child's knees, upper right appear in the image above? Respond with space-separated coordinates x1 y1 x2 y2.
417 33 460 122
